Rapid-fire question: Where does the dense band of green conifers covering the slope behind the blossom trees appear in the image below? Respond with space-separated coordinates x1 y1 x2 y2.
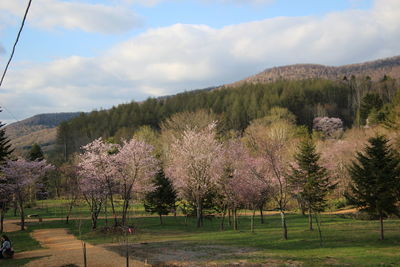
52 76 397 161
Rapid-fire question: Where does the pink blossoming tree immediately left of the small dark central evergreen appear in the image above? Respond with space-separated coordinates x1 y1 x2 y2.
115 138 159 225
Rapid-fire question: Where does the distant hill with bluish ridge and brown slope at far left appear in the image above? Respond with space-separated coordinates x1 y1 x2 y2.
5 112 80 155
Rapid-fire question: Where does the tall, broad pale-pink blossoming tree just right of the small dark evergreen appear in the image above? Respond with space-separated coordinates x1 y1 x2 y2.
166 123 223 227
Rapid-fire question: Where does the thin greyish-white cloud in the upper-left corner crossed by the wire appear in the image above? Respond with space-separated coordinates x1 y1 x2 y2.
0 0 142 34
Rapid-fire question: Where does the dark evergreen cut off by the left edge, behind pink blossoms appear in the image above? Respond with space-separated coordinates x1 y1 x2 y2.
0 114 14 233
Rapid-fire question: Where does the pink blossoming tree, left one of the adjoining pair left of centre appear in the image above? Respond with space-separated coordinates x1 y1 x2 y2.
79 138 120 226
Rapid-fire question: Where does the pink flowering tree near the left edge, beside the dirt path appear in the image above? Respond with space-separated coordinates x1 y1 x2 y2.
1 159 54 230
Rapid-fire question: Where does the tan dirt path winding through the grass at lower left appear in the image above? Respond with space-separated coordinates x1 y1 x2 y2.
14 229 145 267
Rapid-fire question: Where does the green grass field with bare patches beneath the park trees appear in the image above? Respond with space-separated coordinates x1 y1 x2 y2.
6 214 400 266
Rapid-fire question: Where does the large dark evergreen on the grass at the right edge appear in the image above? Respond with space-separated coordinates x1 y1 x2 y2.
346 135 400 240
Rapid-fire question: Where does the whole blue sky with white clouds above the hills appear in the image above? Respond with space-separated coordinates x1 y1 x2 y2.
0 0 400 123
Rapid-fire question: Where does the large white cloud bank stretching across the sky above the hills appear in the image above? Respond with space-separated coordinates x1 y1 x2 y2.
0 0 400 121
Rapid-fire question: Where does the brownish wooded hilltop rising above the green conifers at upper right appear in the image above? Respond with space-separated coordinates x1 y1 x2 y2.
224 56 400 87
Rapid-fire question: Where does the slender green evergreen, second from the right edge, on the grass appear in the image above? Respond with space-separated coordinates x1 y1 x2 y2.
288 138 335 234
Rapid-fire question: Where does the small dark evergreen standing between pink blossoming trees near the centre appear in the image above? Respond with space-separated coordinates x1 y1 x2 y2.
144 169 176 224
